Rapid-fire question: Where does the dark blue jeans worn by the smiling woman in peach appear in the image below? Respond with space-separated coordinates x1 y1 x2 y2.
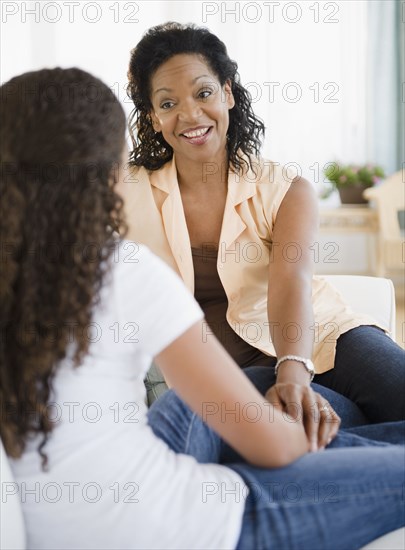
238 326 405 428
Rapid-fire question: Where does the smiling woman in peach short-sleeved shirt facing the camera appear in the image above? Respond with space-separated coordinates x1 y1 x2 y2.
121 23 405 439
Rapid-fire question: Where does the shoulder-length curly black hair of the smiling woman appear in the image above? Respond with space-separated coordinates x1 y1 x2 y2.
127 22 264 170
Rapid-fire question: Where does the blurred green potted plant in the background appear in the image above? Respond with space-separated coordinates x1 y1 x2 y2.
322 162 385 208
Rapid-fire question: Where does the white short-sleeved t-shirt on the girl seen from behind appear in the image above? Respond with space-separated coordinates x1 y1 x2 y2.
11 241 246 550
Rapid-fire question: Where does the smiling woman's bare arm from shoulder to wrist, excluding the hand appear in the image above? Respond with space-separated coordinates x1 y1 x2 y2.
268 178 319 378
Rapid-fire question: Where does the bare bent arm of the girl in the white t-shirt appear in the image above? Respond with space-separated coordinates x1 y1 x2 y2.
155 322 308 467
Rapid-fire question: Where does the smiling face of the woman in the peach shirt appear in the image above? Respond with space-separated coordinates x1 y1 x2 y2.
150 54 235 167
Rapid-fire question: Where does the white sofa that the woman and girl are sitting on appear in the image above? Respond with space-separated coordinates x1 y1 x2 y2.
0 275 405 550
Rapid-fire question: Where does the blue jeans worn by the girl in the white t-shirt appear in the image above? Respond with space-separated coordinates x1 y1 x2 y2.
148 390 405 550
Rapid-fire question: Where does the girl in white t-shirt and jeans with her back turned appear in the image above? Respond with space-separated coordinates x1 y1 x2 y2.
0 69 404 550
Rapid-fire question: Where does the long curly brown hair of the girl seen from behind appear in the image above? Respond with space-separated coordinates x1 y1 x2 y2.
0 68 126 467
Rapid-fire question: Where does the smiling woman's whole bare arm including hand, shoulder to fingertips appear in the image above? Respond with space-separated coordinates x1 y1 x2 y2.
266 178 340 450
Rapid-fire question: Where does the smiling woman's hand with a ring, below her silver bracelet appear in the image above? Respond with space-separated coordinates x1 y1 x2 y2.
265 382 341 451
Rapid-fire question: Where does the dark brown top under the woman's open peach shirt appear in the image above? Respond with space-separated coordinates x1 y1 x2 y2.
191 245 274 368
